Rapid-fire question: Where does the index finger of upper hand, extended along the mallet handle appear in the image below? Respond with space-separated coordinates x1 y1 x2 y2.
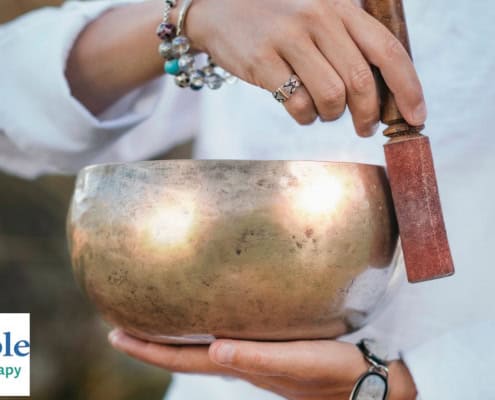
340 7 426 126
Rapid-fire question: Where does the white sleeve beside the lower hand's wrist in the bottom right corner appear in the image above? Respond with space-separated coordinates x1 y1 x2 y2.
402 320 495 400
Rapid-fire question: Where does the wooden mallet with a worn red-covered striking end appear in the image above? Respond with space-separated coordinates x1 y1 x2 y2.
363 0 454 282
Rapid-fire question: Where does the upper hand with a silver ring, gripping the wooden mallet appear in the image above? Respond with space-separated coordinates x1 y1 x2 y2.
185 0 426 136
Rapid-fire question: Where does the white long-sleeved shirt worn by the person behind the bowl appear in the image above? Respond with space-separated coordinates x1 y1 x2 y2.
0 0 495 400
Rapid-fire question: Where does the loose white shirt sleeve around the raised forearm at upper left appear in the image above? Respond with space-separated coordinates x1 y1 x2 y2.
0 1 198 177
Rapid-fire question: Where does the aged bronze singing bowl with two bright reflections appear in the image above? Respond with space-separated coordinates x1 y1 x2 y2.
67 160 399 343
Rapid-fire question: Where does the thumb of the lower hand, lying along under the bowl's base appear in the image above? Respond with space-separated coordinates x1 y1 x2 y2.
209 340 367 383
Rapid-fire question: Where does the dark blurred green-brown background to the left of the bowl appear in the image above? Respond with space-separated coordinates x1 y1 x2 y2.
0 0 195 400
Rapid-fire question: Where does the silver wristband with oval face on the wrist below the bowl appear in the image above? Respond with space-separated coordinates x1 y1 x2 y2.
349 339 388 400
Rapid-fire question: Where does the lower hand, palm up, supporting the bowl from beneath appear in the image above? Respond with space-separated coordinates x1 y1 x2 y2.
109 330 416 400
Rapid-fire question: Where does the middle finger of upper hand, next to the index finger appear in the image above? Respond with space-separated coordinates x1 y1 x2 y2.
313 14 380 136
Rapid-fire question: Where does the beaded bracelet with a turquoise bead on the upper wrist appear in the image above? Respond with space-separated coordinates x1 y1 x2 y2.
156 0 237 90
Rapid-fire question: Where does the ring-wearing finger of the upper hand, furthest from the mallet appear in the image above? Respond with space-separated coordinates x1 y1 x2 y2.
249 52 318 125
